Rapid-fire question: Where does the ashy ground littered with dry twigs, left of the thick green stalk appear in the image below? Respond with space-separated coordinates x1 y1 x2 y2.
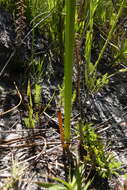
0 72 65 189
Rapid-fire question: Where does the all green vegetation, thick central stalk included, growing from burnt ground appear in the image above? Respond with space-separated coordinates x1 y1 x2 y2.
0 0 127 190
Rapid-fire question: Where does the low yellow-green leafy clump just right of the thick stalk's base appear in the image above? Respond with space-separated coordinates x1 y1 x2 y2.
79 123 121 178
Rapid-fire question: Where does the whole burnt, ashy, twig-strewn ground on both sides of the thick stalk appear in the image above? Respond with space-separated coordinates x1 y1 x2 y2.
0 60 127 190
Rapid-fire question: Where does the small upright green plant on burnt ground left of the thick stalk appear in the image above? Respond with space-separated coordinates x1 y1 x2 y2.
24 58 43 128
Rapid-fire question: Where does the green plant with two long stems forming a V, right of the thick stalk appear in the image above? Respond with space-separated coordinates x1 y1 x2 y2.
85 0 126 93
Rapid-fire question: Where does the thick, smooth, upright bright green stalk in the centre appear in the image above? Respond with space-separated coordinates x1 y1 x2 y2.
64 0 76 144
